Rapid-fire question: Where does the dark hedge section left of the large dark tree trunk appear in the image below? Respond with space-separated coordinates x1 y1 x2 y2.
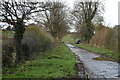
2 31 14 67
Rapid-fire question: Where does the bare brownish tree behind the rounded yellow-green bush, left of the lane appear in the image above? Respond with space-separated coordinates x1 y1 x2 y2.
38 1 68 41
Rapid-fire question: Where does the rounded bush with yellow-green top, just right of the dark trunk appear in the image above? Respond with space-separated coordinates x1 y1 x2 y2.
22 24 53 59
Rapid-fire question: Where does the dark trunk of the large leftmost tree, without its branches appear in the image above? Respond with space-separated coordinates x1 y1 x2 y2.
14 22 25 64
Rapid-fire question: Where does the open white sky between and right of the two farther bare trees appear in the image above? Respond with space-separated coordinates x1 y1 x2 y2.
62 0 120 26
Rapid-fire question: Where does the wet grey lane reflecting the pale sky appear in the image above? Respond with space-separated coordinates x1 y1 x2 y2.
66 43 120 80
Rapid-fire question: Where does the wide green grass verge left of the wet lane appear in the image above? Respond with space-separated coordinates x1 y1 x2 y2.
3 44 76 78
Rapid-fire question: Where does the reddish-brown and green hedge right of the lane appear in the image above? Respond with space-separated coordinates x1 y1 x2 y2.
90 27 118 52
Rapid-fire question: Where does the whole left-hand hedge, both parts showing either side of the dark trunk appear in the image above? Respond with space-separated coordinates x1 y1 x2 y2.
1 25 54 67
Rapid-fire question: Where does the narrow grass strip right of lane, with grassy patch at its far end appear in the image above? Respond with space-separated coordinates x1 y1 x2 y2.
63 34 120 61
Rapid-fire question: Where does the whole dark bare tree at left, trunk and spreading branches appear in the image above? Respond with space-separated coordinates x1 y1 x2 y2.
0 0 46 63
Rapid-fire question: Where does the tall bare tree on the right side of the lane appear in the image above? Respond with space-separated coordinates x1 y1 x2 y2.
73 1 100 42
